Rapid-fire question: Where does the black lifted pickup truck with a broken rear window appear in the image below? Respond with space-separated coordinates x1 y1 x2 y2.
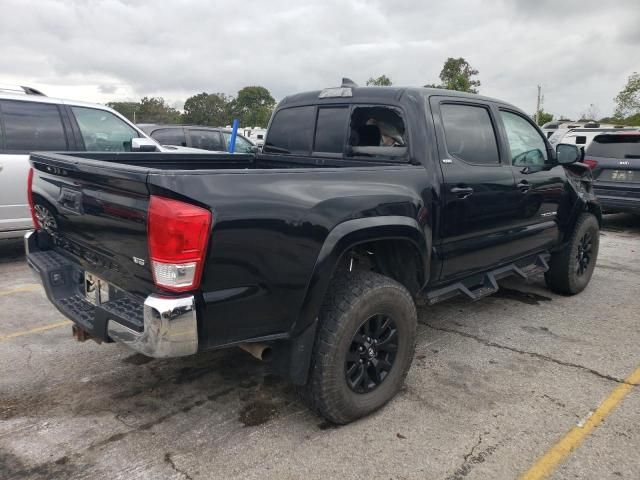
25 84 601 423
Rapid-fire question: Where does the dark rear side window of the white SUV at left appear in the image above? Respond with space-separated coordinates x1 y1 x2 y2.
0 100 68 152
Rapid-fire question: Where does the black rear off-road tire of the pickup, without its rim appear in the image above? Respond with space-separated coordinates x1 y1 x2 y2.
301 271 417 424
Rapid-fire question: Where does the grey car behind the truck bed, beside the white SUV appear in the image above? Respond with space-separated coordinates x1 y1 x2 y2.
138 123 254 153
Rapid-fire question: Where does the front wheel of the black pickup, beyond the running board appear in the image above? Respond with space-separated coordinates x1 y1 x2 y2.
545 213 600 295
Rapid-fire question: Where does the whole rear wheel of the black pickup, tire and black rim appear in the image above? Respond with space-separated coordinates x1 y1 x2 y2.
303 271 417 424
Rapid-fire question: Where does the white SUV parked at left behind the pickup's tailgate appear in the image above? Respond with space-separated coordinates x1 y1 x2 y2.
0 84 168 239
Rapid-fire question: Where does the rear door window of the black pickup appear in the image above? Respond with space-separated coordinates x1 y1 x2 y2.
440 103 500 165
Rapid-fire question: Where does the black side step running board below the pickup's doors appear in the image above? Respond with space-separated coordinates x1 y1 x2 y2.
423 253 551 305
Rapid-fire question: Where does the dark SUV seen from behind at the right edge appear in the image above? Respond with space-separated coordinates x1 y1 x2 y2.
583 130 640 214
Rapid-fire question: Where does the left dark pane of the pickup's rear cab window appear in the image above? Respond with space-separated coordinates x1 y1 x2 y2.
262 106 316 155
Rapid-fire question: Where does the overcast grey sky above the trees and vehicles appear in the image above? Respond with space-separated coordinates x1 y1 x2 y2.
0 0 640 117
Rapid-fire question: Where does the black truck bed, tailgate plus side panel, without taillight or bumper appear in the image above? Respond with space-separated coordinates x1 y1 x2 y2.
31 152 431 347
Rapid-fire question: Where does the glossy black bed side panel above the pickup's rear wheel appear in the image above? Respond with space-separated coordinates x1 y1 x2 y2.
149 165 433 347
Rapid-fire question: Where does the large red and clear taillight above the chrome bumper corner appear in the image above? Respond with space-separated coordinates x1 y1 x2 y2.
147 195 212 292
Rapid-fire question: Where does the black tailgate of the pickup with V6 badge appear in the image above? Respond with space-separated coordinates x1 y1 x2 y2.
31 153 155 295
